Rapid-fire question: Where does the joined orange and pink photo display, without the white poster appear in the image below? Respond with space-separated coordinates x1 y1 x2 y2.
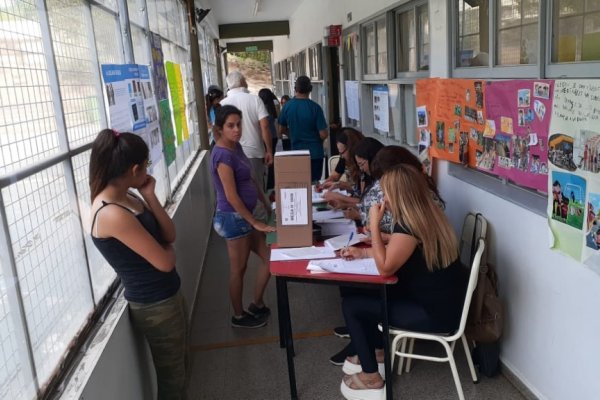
416 78 553 192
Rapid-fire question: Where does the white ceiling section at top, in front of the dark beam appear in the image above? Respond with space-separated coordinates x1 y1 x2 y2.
203 0 302 25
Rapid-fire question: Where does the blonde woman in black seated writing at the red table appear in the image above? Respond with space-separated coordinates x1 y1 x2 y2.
341 165 467 399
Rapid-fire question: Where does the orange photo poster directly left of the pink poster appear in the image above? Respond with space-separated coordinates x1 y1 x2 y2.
430 79 485 165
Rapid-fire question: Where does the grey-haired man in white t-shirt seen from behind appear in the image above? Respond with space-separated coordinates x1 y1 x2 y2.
221 71 273 190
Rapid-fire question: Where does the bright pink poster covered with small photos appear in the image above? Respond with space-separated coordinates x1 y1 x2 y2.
477 80 554 192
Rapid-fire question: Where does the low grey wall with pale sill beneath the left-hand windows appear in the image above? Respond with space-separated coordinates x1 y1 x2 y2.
61 152 214 400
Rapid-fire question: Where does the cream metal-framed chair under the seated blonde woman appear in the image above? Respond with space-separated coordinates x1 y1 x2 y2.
390 238 485 400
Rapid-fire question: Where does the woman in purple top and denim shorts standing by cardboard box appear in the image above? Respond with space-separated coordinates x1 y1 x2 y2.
211 105 275 328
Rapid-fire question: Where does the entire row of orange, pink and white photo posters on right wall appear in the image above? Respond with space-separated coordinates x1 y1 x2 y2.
416 78 600 273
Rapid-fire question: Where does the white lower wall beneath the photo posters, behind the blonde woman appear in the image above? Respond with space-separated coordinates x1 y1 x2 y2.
436 162 600 399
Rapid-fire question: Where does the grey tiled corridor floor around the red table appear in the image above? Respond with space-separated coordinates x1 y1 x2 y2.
188 233 524 400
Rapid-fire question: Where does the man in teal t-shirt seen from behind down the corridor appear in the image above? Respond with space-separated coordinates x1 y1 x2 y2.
278 76 328 182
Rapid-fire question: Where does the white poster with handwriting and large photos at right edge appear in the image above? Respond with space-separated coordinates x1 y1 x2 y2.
546 79 600 264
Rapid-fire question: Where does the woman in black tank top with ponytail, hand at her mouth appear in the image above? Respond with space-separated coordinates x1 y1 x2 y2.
90 129 187 399
